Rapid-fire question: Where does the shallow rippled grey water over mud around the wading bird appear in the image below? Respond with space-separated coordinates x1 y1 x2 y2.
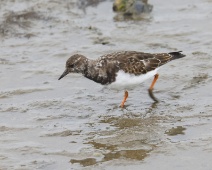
0 0 212 170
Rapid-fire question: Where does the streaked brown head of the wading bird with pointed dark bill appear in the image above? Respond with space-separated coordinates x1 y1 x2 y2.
58 54 88 80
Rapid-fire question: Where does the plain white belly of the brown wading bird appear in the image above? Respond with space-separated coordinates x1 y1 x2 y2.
108 68 159 89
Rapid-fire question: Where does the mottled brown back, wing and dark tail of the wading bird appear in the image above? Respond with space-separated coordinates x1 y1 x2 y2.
98 51 185 75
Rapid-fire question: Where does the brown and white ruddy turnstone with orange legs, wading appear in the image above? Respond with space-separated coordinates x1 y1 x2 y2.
58 51 185 108
